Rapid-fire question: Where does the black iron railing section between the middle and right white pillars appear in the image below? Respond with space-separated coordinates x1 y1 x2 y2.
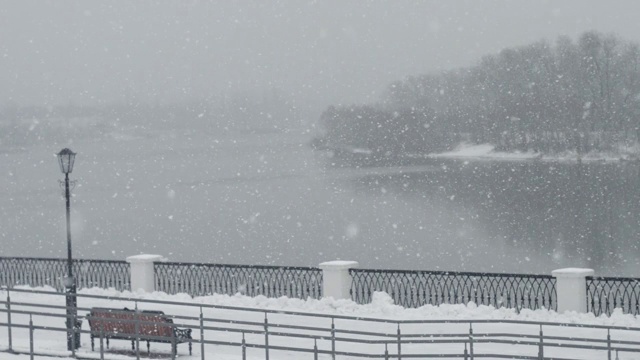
349 269 557 310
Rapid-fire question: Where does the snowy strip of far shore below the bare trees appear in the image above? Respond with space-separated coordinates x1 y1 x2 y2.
428 143 639 161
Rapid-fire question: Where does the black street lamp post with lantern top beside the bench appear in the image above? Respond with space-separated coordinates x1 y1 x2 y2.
58 148 80 351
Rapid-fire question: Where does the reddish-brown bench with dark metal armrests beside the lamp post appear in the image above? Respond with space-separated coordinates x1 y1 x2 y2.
87 308 192 355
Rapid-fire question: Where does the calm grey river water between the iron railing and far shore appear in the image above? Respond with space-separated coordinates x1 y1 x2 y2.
0 131 640 276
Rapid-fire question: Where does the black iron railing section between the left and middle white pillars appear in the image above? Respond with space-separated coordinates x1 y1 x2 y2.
155 262 322 299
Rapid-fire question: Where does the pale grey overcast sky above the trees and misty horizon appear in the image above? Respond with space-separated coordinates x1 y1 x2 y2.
0 0 640 119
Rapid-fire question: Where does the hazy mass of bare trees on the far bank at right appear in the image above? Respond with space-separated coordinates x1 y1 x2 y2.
323 31 640 162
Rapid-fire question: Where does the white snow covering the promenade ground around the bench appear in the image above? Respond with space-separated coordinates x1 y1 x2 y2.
0 289 640 360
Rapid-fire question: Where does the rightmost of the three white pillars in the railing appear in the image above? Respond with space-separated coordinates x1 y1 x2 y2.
551 268 594 313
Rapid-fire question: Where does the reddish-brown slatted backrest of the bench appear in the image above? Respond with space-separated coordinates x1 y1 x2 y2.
89 308 173 337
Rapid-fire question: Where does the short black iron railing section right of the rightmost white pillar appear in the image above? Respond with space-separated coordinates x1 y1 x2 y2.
586 276 640 316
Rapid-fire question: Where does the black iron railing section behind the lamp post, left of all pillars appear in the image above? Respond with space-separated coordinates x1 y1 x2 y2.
0 257 131 291
